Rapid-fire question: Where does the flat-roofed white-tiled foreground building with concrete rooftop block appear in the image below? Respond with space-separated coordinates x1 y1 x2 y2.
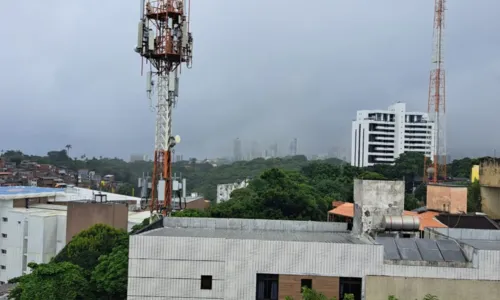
128 180 500 300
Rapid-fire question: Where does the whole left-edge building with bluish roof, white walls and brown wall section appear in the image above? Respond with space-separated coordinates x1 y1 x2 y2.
0 186 150 285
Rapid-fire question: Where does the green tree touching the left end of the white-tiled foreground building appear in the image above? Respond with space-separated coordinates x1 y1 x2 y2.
92 245 128 300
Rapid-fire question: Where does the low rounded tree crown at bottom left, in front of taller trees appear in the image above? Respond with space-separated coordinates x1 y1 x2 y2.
9 262 93 300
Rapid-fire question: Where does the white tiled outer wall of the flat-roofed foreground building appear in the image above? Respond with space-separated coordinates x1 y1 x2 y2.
127 235 500 300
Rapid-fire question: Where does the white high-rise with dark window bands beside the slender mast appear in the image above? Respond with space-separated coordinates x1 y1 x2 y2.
351 102 435 167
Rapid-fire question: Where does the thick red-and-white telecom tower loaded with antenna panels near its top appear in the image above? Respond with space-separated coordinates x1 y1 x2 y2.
135 0 193 216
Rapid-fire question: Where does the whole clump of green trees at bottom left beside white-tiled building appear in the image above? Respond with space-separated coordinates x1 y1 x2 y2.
9 224 128 300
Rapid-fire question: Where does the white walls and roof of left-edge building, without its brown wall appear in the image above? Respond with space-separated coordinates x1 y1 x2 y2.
0 186 146 285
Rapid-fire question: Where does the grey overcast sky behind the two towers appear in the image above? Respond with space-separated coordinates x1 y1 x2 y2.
0 0 500 159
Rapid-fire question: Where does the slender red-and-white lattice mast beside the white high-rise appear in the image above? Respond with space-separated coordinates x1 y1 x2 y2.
424 0 447 183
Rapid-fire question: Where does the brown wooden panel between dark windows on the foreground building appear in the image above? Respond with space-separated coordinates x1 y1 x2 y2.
279 275 339 300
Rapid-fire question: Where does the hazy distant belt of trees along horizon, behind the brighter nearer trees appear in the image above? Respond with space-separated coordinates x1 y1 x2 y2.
1 149 485 207
